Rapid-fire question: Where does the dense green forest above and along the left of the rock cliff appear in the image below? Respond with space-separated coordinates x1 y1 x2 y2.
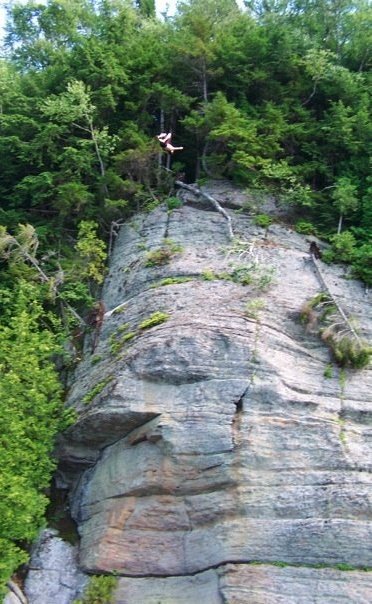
0 0 372 596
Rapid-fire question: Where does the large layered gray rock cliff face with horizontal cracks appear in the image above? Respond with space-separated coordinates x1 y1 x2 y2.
60 184 372 604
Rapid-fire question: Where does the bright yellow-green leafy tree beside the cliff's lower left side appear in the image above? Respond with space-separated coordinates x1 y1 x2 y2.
0 281 66 585
